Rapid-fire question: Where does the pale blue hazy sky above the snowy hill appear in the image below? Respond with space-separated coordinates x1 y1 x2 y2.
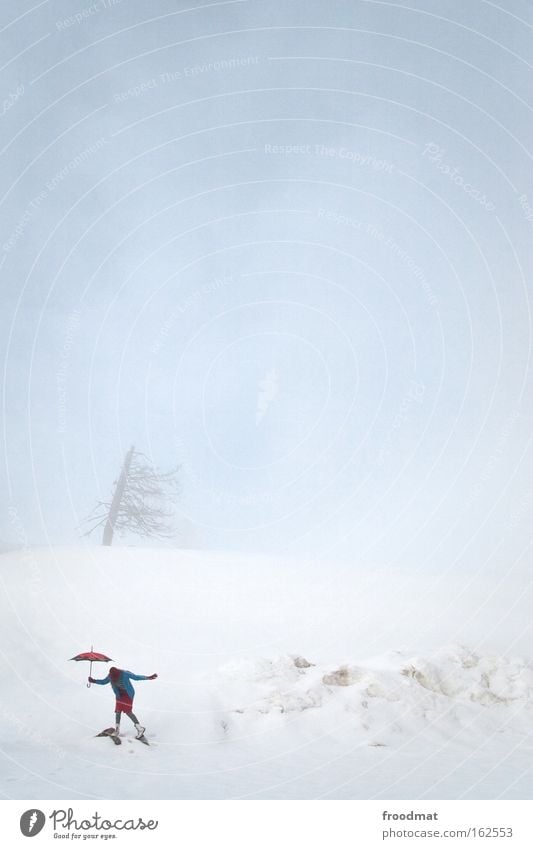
0 0 533 566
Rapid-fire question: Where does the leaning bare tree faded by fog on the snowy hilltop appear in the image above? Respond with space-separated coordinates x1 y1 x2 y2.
84 445 179 545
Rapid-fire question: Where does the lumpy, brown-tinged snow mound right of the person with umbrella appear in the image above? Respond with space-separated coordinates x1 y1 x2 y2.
218 646 533 725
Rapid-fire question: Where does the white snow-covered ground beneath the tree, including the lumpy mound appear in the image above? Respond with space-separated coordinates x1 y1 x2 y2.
0 547 533 799
